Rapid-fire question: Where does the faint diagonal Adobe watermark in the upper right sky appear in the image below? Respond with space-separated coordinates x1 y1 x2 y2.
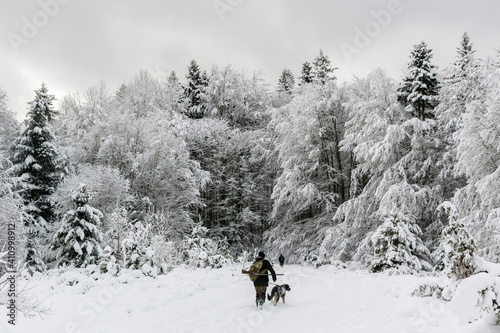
340 0 403 62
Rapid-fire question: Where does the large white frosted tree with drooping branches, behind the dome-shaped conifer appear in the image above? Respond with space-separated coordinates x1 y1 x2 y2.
321 70 441 263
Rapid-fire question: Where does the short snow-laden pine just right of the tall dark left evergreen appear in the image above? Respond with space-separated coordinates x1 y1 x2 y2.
52 184 103 267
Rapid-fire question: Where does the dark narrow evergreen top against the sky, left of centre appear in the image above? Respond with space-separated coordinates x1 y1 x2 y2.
184 60 208 119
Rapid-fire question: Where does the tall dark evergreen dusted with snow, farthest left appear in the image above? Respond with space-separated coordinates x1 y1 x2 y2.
12 84 66 271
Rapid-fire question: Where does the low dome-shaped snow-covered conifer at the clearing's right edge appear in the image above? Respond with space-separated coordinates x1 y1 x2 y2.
370 213 431 274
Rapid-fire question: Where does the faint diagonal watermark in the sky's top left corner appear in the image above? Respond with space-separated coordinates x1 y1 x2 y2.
7 0 71 52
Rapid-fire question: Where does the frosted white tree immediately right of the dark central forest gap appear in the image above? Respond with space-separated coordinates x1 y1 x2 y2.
269 82 348 217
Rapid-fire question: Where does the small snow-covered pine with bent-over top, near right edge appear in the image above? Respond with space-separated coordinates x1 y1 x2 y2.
439 201 477 280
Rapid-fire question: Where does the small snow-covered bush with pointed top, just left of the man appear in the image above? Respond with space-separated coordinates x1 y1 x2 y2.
182 222 231 268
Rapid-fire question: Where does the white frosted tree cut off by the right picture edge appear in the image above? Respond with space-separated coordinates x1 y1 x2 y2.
453 53 500 261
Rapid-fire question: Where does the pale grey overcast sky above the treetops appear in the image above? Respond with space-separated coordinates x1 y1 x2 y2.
0 0 500 120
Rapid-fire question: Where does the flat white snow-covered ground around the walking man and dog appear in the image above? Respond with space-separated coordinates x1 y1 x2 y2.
0 265 500 333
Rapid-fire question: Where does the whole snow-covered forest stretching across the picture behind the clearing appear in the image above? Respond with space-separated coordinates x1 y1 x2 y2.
0 34 500 277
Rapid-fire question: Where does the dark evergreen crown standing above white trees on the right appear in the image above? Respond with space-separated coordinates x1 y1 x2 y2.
398 42 439 120
